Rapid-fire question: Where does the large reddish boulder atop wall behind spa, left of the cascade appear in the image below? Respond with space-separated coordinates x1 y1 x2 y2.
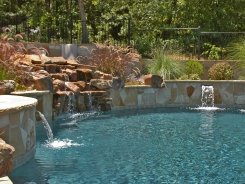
32 72 53 92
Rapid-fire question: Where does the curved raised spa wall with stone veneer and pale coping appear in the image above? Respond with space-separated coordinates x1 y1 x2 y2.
0 95 37 167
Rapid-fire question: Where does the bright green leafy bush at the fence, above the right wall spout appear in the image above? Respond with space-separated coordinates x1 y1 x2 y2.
202 43 225 60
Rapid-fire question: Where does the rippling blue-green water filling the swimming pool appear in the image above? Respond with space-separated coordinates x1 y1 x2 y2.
10 108 245 184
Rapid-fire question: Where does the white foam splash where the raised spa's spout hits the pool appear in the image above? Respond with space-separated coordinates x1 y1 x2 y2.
46 139 84 149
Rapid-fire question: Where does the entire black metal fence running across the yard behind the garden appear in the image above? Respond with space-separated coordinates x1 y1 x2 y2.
0 17 245 60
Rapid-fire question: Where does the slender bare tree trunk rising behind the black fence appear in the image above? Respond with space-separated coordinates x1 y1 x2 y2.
78 0 89 43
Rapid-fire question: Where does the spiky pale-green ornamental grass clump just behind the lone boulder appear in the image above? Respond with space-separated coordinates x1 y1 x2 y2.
149 47 182 79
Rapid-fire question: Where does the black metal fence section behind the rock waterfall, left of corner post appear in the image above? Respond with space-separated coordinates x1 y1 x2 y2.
0 19 131 45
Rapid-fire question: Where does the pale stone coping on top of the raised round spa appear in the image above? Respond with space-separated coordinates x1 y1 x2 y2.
0 95 37 115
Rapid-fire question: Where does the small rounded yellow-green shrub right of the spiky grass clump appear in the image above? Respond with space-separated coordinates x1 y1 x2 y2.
185 60 203 78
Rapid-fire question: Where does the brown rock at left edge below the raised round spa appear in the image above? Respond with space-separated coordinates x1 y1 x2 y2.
0 138 15 177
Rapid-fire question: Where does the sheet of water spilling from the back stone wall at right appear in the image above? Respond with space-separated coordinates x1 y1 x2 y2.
201 86 214 107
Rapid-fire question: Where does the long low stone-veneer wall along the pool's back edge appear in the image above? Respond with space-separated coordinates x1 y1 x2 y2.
111 80 245 109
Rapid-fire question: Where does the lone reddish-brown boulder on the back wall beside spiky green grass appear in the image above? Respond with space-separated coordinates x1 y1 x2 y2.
143 74 165 88
